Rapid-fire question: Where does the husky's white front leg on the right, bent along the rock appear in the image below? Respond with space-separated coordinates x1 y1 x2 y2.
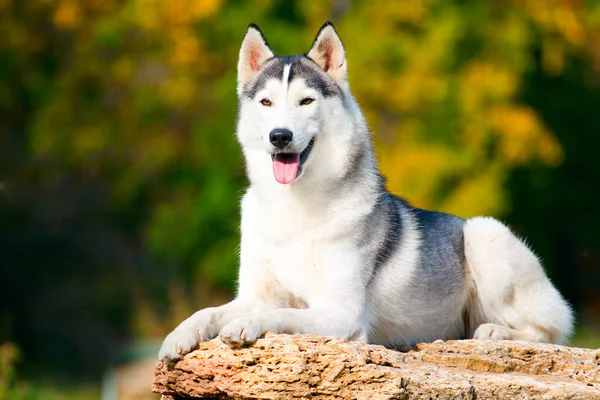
219 243 369 347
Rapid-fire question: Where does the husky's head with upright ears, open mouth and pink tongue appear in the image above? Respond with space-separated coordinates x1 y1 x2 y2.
237 23 351 184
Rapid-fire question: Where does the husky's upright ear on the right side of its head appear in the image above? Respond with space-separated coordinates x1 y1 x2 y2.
306 22 348 82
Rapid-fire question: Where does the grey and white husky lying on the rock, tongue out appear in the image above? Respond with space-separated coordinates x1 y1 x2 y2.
158 23 573 363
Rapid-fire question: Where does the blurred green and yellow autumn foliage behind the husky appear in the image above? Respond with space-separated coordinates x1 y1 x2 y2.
0 0 600 399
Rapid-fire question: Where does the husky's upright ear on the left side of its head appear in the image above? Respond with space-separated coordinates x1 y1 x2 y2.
238 24 275 87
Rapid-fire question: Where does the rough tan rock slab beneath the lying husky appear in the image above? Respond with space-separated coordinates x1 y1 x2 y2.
153 334 600 400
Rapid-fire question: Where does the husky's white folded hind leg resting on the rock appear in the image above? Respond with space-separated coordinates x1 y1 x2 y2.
464 217 573 343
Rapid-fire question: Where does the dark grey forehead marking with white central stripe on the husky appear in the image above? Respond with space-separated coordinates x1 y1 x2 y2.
243 54 343 98
